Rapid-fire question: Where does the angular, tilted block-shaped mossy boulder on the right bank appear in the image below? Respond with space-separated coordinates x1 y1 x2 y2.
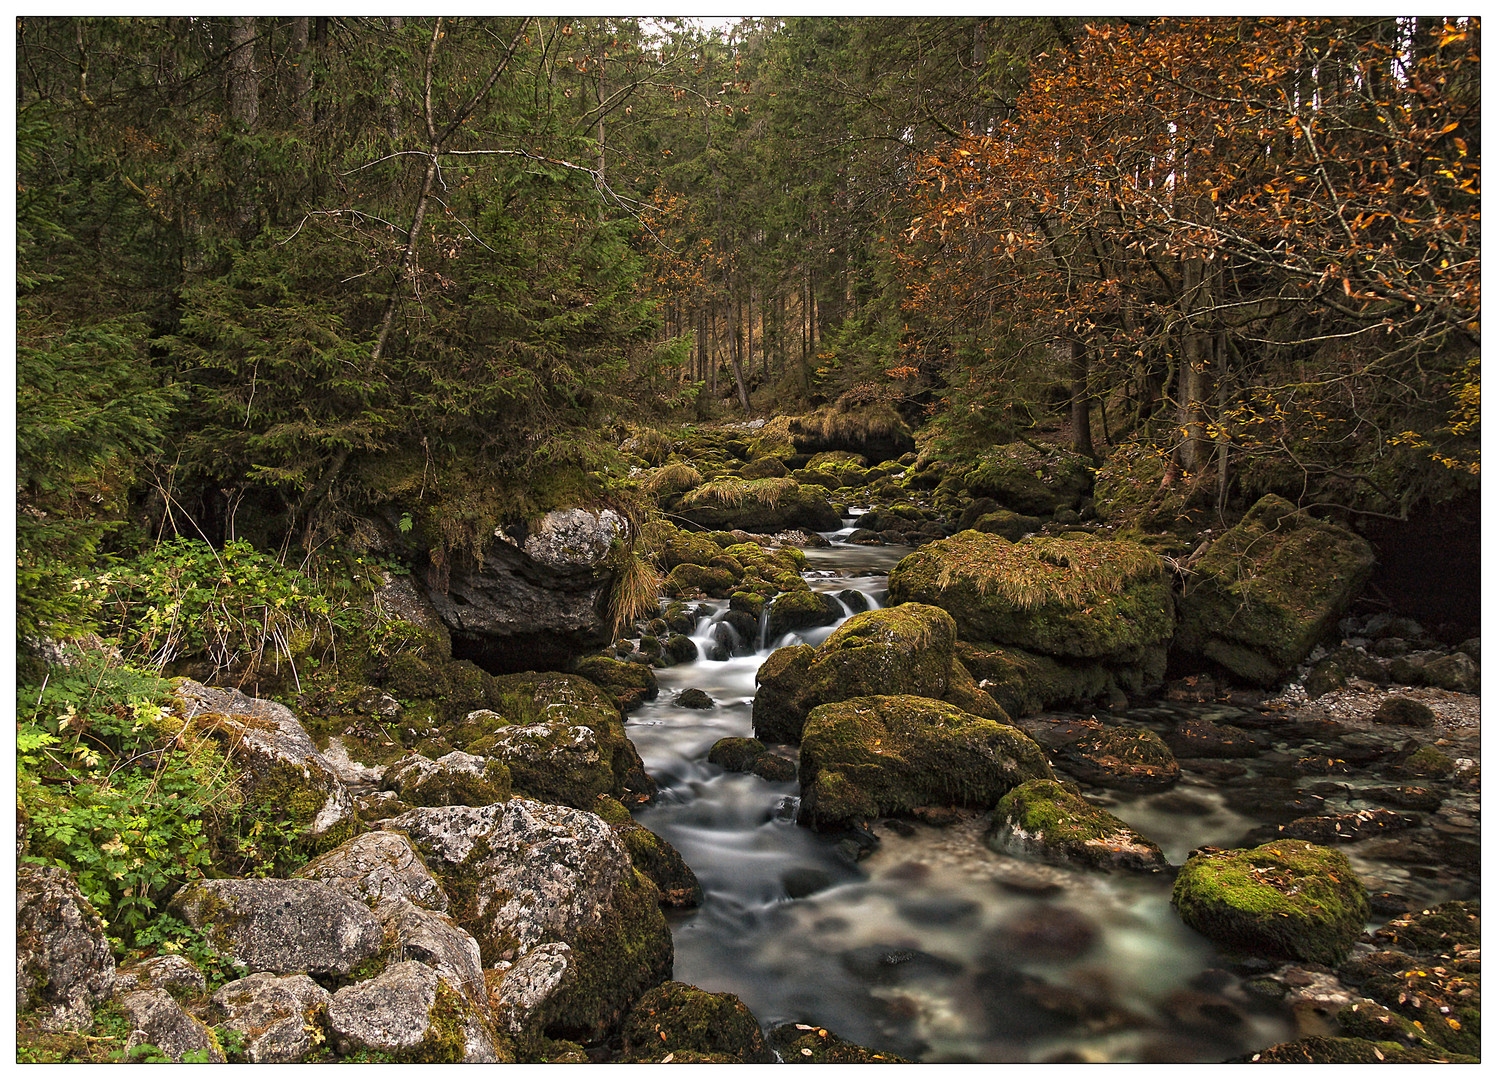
1175 494 1374 686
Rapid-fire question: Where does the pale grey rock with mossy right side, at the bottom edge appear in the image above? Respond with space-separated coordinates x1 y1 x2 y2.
328 960 499 1062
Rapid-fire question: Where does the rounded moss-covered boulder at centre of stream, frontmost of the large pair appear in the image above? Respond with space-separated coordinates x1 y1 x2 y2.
799 695 1054 830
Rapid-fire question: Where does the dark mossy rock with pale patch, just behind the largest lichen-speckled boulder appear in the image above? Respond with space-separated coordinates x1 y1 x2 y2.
466 671 656 809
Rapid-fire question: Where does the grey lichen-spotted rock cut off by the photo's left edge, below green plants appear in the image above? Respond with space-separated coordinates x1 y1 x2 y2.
15 863 115 1031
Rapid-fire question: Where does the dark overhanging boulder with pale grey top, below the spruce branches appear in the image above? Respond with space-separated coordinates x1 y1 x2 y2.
416 509 623 671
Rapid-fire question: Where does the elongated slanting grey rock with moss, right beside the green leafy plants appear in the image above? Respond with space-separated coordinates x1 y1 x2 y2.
174 679 358 846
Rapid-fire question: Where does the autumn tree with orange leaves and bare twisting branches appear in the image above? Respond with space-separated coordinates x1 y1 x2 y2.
903 18 1481 515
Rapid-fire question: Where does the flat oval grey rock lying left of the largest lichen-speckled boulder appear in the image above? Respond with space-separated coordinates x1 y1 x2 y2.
171 878 385 977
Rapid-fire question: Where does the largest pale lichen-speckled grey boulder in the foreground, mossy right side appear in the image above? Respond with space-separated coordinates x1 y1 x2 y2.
383 798 674 1037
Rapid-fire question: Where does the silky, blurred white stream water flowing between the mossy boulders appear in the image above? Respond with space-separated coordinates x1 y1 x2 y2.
629 530 1377 1062
